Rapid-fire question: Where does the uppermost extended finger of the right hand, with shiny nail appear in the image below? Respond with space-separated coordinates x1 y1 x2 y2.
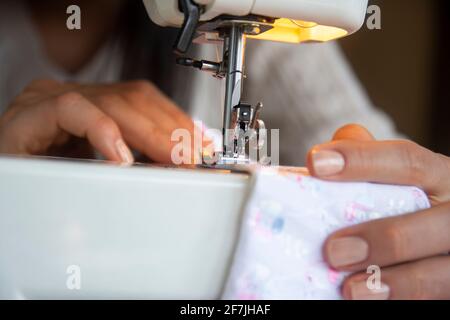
307 140 450 201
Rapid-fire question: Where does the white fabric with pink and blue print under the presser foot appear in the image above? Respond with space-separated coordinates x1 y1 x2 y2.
223 168 430 300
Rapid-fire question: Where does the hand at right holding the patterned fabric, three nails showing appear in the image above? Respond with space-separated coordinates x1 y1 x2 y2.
308 125 450 299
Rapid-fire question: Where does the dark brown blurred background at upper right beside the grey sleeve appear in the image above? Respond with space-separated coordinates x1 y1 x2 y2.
341 0 450 155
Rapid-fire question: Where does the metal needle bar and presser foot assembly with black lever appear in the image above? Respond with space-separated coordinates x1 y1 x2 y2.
175 0 270 164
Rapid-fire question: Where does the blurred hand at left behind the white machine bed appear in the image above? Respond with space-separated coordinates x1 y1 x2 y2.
0 80 200 164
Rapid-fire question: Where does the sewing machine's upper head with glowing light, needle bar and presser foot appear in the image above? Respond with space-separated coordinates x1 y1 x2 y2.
144 0 368 164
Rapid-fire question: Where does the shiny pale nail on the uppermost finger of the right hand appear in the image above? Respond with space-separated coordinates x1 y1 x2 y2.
312 150 345 177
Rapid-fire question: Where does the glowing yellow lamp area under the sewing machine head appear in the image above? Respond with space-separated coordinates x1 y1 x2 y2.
248 18 348 43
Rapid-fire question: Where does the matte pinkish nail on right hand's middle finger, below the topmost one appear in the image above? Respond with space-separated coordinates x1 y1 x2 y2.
327 237 369 268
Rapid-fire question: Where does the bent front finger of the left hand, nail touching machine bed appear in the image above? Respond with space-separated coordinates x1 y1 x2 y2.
6 92 133 164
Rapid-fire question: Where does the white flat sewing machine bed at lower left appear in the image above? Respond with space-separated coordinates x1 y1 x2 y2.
0 157 251 299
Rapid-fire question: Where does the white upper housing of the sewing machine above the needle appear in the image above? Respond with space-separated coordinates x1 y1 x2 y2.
144 0 368 41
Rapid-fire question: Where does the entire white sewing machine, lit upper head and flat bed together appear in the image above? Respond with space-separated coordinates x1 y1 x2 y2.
0 0 367 299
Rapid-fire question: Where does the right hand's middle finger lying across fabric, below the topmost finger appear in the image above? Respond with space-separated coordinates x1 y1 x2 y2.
324 203 450 271
